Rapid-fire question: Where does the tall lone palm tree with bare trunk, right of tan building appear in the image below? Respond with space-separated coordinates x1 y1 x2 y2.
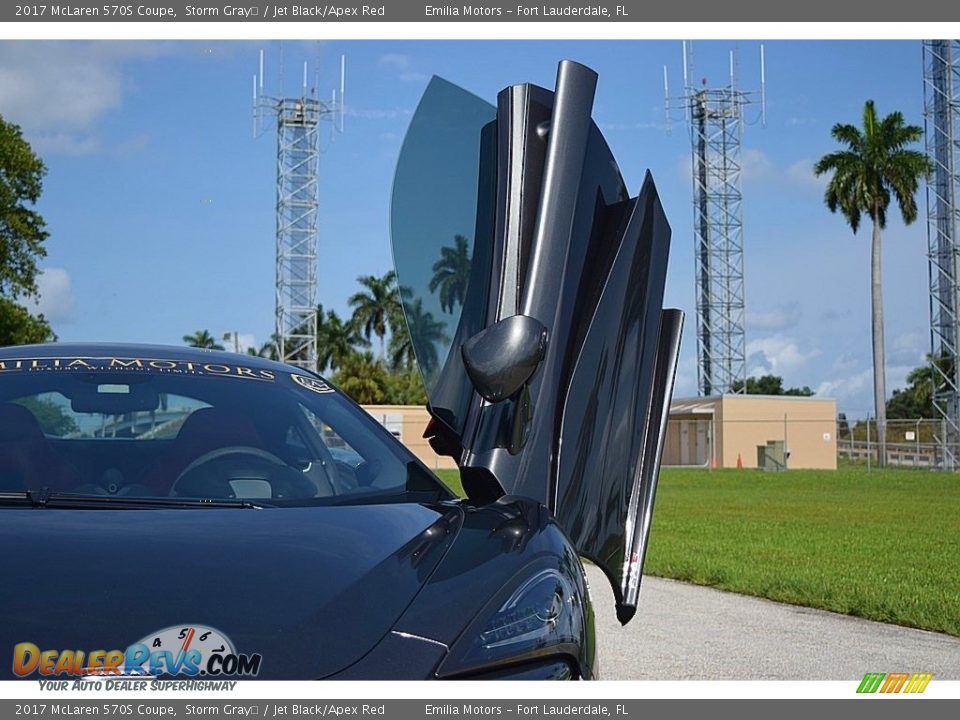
813 100 933 465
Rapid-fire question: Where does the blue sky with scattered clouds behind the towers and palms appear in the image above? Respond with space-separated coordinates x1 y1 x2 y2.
0 40 929 416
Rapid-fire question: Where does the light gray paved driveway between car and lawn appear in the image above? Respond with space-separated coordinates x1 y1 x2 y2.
587 566 960 680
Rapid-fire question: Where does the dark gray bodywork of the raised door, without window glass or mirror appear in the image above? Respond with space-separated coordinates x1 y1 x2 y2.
395 61 682 622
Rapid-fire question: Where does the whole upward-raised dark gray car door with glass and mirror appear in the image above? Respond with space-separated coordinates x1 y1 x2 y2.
391 61 683 623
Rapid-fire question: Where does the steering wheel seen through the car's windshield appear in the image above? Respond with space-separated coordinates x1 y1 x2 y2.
170 445 316 498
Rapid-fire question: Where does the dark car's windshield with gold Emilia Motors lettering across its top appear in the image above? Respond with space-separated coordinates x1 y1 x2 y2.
0 357 449 506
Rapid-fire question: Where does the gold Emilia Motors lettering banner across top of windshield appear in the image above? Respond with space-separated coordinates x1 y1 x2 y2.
0 357 276 382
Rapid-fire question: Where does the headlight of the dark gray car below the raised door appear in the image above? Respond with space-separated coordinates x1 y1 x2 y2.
439 568 585 676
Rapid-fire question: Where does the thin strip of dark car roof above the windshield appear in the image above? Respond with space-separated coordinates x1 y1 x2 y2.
0 342 316 374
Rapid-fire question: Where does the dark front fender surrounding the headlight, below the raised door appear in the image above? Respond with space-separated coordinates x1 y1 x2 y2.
332 497 596 679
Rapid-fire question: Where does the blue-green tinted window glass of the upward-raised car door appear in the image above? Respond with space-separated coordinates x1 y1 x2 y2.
390 77 496 436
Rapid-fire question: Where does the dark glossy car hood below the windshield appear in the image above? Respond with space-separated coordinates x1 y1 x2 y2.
0 504 461 679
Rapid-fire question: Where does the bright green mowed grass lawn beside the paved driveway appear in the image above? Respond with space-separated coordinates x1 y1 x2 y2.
440 466 960 636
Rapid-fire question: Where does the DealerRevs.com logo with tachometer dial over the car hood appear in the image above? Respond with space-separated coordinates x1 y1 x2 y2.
13 625 263 679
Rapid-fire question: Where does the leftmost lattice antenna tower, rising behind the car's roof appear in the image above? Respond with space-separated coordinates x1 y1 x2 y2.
253 50 346 370
